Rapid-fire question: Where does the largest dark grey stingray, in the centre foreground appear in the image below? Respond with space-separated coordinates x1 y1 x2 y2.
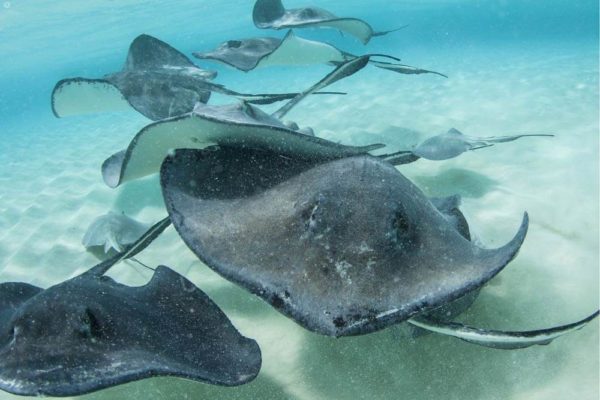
161 148 588 348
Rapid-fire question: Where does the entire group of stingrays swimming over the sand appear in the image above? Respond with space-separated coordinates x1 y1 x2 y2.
0 0 598 396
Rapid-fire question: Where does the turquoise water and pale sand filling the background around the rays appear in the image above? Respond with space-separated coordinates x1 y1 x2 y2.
0 0 599 399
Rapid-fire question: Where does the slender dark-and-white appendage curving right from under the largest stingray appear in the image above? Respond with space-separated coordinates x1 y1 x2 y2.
408 311 598 350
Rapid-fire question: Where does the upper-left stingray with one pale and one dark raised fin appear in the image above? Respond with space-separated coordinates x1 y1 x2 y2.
52 35 338 120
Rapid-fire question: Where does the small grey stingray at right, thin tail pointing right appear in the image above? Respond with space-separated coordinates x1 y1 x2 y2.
412 128 554 160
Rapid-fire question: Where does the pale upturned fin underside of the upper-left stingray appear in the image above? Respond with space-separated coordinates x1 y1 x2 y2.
52 78 132 118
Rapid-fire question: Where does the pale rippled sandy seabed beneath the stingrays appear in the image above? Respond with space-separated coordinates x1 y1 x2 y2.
0 41 599 400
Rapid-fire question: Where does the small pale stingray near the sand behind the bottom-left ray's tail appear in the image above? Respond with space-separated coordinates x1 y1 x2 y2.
82 211 150 253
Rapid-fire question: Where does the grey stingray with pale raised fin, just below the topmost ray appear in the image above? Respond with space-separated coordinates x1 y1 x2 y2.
193 30 447 77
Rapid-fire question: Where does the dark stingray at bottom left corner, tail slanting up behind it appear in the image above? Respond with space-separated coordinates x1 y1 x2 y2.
0 218 261 396
